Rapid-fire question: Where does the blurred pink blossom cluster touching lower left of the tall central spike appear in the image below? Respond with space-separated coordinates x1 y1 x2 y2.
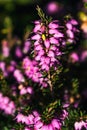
23 57 47 87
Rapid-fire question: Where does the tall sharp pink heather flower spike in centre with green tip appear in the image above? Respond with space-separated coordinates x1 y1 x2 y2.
27 6 64 91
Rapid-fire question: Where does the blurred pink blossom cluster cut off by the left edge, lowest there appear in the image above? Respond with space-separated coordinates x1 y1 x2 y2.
0 92 16 115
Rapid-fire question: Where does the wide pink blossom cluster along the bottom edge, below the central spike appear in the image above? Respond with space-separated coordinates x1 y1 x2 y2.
16 111 62 130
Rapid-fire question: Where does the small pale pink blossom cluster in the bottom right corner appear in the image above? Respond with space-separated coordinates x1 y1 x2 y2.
74 120 87 130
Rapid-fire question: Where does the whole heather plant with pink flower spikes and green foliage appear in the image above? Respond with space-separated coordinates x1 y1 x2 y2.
0 6 87 130
